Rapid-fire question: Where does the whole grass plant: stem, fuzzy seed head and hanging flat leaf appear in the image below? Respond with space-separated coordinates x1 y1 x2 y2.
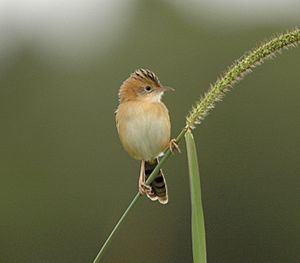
94 28 300 263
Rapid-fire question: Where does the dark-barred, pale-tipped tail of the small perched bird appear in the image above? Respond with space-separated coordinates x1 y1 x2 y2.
145 158 168 204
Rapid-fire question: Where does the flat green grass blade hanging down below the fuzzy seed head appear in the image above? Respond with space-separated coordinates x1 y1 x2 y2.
185 130 206 263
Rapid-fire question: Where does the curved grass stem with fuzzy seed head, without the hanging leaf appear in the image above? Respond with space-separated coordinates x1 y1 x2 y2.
94 29 300 263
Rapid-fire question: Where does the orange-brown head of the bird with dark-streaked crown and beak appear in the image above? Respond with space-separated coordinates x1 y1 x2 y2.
119 69 174 102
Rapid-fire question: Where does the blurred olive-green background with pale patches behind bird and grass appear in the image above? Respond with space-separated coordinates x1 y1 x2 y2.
0 0 300 263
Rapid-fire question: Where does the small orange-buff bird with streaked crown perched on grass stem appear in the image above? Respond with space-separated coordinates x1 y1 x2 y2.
116 68 179 204
